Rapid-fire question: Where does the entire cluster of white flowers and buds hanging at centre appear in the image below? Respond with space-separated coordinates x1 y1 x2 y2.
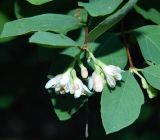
45 50 123 98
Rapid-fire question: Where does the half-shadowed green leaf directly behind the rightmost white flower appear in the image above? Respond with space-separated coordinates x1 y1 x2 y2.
90 33 127 68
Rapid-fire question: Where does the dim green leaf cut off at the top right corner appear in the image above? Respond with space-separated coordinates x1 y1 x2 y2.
135 6 160 24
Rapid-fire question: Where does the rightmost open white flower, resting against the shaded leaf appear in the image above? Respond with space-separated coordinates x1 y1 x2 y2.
102 65 123 88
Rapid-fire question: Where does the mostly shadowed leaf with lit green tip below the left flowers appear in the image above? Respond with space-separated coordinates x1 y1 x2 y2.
51 93 86 121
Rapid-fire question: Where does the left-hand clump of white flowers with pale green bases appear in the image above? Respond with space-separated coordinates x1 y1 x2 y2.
45 69 91 98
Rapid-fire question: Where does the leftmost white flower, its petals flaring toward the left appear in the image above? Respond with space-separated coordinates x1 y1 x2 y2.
45 72 70 94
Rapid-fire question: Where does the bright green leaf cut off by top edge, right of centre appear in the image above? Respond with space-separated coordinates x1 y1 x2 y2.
78 0 123 17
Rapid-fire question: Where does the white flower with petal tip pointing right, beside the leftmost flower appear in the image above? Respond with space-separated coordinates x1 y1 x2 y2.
70 78 91 98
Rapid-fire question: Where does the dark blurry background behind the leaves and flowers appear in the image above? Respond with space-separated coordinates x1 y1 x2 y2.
0 0 160 140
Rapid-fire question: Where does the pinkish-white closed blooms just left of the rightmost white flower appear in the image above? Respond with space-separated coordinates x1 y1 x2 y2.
88 72 104 92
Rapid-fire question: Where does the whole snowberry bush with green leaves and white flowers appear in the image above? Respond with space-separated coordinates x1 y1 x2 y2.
0 0 160 134
